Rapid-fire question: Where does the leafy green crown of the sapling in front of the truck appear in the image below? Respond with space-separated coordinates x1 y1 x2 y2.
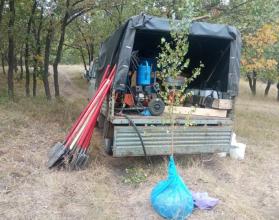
158 4 202 105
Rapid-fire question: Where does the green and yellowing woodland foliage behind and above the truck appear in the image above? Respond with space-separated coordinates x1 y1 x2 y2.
0 0 279 97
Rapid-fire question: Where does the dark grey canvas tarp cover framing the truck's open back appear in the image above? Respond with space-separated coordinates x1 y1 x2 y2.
96 14 241 96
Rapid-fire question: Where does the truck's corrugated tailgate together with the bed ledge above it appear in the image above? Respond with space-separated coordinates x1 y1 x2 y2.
110 115 232 157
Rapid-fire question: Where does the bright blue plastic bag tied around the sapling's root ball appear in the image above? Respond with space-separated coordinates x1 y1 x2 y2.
151 156 194 220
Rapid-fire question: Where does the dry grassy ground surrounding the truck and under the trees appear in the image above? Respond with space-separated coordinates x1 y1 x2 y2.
0 66 279 220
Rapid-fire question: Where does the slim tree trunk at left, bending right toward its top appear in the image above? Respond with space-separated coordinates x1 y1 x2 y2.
24 0 37 96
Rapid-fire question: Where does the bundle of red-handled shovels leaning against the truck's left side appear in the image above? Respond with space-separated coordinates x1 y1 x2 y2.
48 65 116 169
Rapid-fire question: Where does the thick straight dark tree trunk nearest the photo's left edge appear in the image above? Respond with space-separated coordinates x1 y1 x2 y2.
8 0 15 99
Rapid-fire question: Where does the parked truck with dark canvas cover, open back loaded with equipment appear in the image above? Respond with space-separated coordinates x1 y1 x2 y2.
89 14 241 157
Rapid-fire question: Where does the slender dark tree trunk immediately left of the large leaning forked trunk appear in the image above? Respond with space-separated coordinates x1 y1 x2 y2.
43 17 53 100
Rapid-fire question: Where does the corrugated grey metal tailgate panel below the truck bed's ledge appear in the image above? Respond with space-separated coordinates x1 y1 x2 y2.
113 126 232 157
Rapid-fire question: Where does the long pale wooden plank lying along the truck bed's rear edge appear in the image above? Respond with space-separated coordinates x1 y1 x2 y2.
164 106 227 118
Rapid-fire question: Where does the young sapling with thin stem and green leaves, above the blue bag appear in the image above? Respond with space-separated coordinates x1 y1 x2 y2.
157 17 203 155
